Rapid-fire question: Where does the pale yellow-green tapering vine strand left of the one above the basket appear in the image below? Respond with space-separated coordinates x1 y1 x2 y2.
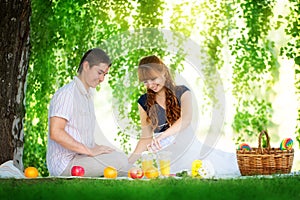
198 0 235 107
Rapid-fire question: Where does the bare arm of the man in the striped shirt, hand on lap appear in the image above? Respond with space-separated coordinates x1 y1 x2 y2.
50 117 114 156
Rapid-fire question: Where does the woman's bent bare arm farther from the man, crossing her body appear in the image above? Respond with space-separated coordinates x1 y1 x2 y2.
152 91 193 149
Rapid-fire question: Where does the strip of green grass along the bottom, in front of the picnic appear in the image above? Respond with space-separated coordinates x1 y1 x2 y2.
0 176 300 200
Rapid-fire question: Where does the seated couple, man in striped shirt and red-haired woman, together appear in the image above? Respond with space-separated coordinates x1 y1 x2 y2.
47 48 240 177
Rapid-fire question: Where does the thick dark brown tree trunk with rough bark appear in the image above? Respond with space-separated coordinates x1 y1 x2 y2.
0 0 31 171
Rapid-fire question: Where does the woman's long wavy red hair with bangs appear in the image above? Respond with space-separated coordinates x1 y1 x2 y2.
138 55 181 130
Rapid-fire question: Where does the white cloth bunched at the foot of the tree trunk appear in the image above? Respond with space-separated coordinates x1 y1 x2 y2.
0 160 25 178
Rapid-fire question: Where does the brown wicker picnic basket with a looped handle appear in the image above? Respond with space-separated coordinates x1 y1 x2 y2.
237 131 294 176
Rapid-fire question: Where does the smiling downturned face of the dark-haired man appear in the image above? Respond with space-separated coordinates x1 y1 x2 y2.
84 63 109 88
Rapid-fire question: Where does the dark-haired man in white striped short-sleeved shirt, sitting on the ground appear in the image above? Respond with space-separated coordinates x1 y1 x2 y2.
47 48 128 176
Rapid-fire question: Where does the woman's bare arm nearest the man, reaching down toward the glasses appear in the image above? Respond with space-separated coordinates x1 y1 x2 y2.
128 105 153 164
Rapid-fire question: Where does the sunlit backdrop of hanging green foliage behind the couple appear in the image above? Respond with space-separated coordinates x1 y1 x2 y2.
23 0 300 176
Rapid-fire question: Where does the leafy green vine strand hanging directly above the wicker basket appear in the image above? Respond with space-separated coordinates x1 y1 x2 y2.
230 0 278 142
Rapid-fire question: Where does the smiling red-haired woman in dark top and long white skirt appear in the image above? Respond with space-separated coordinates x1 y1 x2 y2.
129 56 240 177
